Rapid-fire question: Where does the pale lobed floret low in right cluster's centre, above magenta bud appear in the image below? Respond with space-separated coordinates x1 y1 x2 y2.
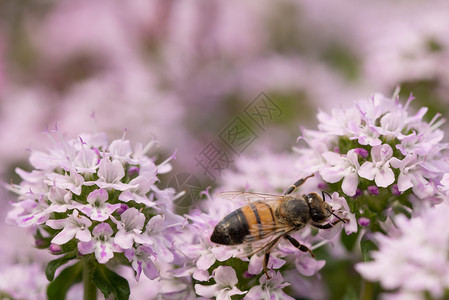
359 144 395 187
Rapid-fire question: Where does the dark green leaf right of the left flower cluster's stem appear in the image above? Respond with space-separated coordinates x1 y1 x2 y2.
93 264 130 300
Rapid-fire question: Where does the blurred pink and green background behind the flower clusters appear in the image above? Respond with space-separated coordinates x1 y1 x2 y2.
0 0 449 299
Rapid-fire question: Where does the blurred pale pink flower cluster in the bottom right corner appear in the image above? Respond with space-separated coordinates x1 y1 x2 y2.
356 203 449 299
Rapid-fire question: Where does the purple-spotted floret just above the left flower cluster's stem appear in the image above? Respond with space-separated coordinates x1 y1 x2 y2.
78 223 120 264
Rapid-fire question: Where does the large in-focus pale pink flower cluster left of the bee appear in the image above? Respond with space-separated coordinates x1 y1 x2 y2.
7 130 184 280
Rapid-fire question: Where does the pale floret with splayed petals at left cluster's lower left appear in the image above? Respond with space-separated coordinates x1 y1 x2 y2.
46 209 92 245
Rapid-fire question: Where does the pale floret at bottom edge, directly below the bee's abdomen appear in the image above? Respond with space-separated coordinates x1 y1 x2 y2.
195 266 246 300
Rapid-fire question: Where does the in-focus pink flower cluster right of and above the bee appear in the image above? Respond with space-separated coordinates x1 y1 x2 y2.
297 94 449 229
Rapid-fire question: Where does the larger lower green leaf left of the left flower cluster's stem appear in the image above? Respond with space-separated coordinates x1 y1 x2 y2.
47 262 83 300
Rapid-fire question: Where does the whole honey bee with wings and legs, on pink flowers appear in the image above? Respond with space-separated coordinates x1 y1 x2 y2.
210 174 348 278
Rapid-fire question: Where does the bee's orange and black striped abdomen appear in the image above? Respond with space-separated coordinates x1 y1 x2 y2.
210 202 276 245
